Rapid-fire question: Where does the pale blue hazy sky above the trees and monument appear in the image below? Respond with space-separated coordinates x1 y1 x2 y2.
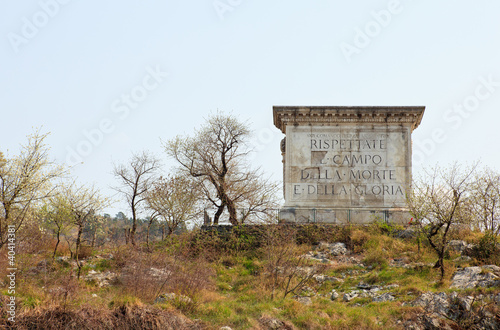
0 0 500 217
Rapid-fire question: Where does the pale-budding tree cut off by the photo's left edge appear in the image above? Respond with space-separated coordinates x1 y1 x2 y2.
0 130 66 248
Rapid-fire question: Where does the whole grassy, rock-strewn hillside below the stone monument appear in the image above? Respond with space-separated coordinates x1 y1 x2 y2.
0 223 500 329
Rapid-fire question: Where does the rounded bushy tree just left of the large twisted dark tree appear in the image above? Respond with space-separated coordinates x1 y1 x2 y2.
147 175 202 235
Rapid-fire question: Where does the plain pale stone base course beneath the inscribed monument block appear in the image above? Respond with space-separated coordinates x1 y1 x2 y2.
279 207 411 225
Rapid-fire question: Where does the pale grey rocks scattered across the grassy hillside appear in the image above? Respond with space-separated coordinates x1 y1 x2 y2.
72 241 500 330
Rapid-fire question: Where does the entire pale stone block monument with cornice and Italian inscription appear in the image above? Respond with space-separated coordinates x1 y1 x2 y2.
273 106 425 223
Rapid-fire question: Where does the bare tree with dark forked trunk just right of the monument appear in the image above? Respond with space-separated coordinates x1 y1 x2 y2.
407 163 477 280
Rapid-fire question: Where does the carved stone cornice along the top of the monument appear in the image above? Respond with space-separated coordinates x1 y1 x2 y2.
273 106 425 133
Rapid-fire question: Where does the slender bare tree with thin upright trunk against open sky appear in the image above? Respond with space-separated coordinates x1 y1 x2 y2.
114 152 160 245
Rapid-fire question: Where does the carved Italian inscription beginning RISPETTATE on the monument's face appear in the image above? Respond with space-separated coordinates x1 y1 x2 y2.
291 131 406 205
